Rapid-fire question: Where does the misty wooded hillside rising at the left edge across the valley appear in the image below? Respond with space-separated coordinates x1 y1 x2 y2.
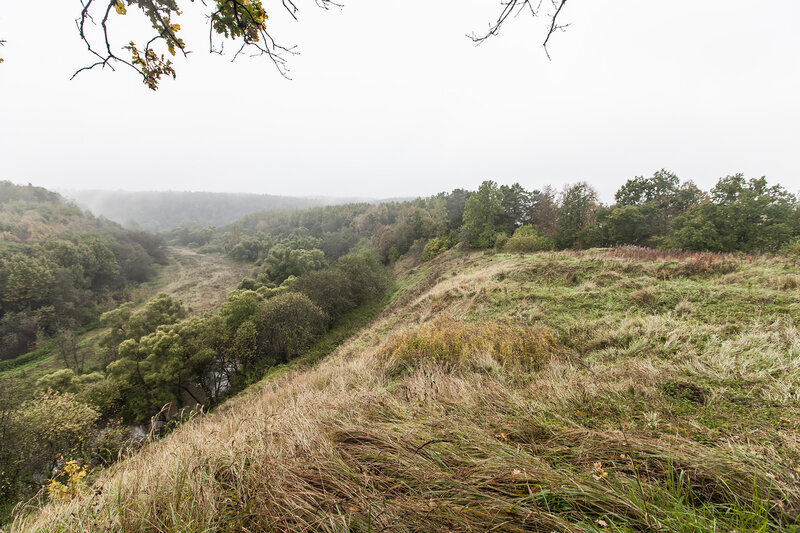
0 181 166 360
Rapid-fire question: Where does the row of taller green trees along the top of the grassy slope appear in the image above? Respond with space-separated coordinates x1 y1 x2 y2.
460 170 800 253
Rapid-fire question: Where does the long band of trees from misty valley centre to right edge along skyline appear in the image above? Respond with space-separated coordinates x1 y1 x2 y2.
180 169 800 264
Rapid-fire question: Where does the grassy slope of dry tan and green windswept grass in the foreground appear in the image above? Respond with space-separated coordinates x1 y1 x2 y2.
13 251 800 531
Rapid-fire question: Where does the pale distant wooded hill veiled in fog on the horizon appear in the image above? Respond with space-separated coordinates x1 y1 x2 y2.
61 190 382 230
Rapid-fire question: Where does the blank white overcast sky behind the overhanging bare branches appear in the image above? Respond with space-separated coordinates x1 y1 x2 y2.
0 0 800 201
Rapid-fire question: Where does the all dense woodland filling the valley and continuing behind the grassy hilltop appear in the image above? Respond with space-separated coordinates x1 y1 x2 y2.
0 170 800 520
